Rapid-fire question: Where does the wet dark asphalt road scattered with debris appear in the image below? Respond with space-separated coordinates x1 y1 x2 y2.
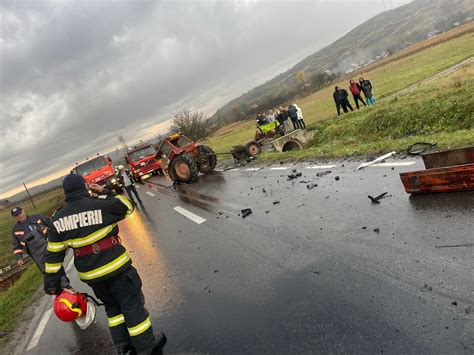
25 162 474 354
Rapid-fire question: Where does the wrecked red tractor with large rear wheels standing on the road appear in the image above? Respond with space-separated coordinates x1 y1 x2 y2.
156 133 217 182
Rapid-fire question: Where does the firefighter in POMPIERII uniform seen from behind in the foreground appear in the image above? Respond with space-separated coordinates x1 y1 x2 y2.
44 174 166 354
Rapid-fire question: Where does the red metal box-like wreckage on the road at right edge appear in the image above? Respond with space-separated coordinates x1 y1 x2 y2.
400 147 474 194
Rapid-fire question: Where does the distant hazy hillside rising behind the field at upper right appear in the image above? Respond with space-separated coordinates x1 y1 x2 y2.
211 0 474 126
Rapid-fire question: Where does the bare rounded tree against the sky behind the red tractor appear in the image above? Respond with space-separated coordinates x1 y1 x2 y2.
171 108 210 140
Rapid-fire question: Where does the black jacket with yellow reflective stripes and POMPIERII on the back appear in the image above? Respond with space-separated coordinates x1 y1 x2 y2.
45 190 133 283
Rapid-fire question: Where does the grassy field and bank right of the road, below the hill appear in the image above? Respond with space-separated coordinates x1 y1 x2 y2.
208 24 474 159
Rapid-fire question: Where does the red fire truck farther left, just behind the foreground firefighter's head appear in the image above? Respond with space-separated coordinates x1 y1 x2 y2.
72 153 123 193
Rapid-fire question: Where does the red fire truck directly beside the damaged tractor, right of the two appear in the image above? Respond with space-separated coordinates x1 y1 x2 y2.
125 143 163 182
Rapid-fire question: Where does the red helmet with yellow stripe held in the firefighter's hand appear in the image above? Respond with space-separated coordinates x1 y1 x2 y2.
54 289 87 322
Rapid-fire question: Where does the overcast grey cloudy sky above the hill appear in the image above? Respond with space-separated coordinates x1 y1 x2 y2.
0 0 409 197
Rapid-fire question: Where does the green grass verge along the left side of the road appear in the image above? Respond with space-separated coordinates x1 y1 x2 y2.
0 190 64 336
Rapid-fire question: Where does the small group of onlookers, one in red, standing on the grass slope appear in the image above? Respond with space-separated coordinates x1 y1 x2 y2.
332 78 375 115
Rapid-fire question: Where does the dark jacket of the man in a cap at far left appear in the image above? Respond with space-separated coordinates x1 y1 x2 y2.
12 214 50 272
